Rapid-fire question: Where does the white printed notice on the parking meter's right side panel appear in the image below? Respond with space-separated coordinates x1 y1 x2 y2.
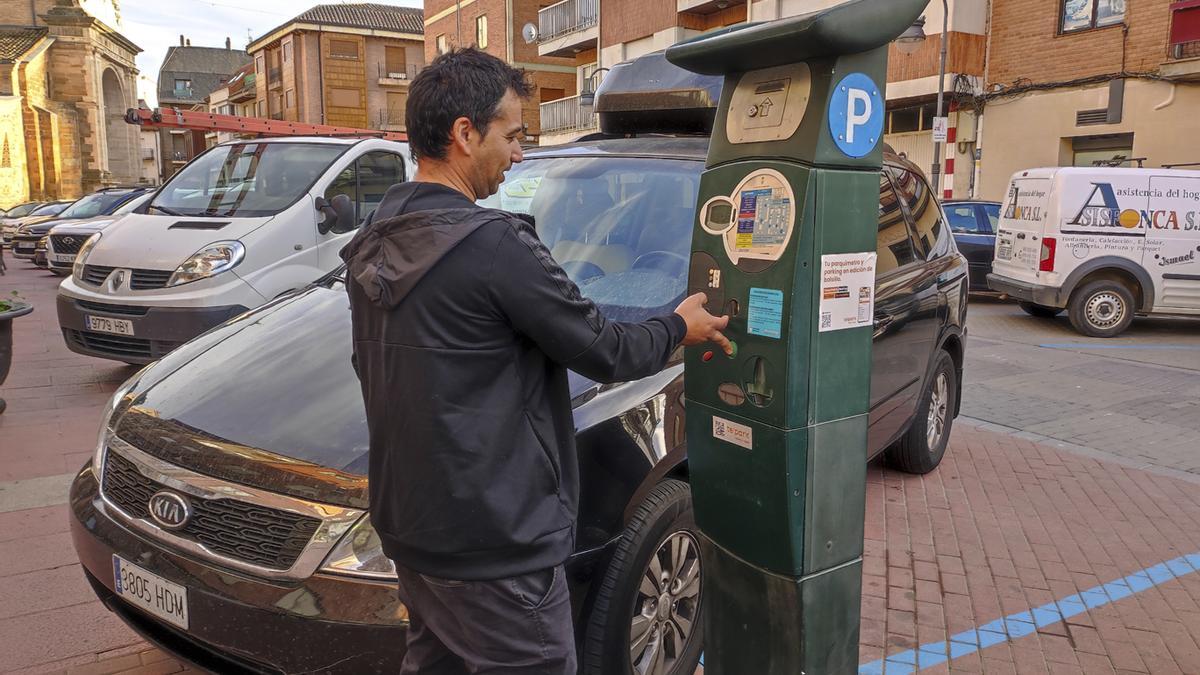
818 253 877 333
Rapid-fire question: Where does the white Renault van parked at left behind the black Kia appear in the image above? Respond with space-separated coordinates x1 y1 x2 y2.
58 137 415 364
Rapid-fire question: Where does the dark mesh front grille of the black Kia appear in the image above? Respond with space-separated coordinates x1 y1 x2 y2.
103 449 320 569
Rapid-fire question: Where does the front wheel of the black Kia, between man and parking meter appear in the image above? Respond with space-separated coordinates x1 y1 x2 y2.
580 479 704 675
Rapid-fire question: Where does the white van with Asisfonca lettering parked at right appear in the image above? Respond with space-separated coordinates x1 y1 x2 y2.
988 167 1200 338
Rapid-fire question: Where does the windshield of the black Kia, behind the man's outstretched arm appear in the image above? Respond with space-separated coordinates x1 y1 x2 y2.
480 157 704 321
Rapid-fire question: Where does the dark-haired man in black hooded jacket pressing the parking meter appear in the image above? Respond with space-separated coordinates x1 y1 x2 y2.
342 49 732 675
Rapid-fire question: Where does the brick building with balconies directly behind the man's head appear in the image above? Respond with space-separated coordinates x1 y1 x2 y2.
425 0 578 142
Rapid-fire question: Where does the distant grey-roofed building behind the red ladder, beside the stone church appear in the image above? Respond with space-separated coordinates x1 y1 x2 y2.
158 35 251 180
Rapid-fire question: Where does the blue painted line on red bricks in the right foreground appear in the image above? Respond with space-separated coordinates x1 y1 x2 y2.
858 551 1200 675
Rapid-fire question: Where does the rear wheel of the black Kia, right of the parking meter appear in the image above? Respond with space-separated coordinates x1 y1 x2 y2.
887 350 959 473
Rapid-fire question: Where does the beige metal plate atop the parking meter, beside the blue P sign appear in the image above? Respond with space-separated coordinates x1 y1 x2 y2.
725 64 812 143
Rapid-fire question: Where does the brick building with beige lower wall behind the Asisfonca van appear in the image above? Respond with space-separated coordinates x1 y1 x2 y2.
977 0 1200 199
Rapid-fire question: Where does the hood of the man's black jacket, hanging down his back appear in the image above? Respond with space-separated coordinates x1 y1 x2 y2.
341 183 523 309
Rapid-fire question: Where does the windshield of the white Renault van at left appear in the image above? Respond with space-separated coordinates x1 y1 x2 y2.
150 141 348 217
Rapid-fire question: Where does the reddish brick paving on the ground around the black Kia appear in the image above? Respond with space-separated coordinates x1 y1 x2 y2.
0 262 1200 675
